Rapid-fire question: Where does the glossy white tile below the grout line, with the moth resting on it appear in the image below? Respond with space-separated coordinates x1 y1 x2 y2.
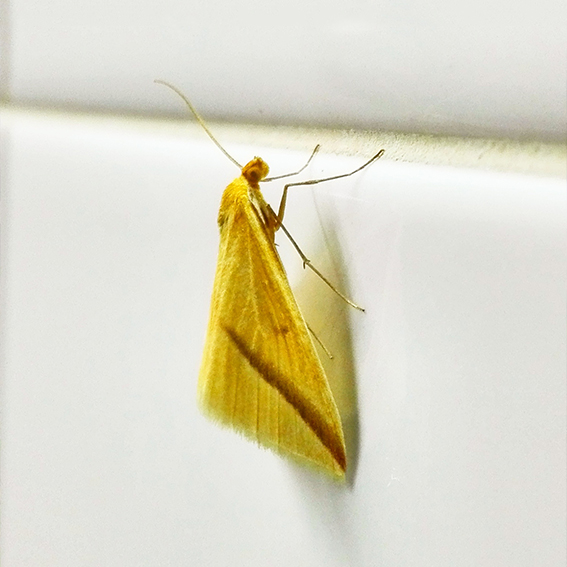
0 112 566 567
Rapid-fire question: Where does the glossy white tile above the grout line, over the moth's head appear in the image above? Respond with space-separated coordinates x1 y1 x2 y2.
4 0 567 141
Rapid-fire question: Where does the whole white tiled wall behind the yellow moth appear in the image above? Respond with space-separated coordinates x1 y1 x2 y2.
0 0 567 567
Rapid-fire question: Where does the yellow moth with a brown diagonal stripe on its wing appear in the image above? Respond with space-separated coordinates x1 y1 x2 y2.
157 81 383 478
